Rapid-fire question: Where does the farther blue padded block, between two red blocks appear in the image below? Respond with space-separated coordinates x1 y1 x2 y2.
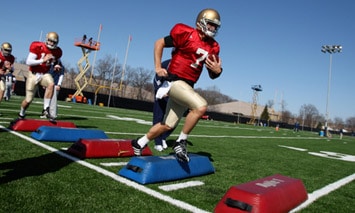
31 126 108 142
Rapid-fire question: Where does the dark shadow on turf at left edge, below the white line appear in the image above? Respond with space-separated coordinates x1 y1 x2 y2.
0 152 73 184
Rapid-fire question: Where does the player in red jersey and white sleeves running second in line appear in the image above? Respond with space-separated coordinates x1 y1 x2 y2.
19 32 63 120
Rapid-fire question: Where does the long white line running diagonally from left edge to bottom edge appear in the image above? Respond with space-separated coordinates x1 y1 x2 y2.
0 125 208 213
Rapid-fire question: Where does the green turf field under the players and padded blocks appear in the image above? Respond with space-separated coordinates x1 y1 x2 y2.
0 96 355 213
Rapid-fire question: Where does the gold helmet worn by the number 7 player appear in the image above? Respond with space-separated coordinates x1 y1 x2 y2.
196 9 221 37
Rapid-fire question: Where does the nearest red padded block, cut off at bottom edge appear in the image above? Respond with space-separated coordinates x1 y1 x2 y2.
214 174 308 213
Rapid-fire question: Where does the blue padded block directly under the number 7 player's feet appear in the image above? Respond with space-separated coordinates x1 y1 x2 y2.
118 154 215 184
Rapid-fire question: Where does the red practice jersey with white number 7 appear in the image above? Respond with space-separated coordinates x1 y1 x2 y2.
169 24 220 83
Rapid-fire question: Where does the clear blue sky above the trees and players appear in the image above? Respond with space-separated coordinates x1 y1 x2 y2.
0 0 355 120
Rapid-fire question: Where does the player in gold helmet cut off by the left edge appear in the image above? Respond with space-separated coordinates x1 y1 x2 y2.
0 42 15 110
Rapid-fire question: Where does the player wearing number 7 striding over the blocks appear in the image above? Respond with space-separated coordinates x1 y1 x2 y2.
131 9 222 162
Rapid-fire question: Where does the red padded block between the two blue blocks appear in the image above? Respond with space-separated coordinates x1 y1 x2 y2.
68 139 153 158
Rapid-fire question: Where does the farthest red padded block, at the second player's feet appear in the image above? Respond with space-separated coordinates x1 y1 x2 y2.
9 119 76 132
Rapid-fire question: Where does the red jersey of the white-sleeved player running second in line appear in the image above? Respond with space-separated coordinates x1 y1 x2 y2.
30 41 63 73
